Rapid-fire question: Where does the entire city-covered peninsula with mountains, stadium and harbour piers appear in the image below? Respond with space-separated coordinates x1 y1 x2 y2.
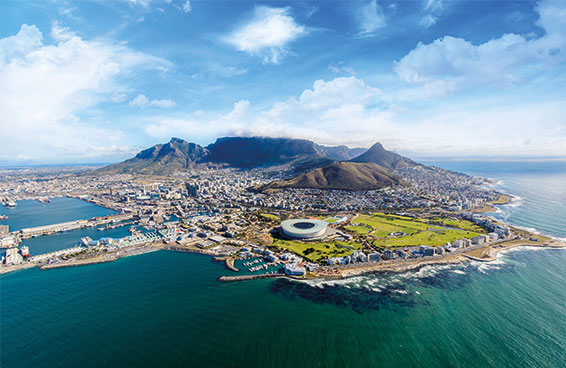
0 137 564 281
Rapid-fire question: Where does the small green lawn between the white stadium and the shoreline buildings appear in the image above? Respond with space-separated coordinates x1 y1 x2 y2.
273 239 362 263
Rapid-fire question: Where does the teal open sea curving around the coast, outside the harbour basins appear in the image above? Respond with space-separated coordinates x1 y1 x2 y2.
0 162 566 368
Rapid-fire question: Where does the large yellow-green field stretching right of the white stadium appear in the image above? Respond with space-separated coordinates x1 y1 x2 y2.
345 213 485 248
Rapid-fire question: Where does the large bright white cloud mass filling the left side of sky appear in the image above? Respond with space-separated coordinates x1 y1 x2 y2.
0 23 168 160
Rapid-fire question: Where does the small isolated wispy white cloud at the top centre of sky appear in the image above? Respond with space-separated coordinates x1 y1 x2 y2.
224 6 306 64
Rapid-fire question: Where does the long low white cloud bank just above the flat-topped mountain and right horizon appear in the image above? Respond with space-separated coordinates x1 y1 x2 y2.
144 73 566 157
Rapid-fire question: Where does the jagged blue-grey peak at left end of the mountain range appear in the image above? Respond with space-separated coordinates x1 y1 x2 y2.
97 138 208 175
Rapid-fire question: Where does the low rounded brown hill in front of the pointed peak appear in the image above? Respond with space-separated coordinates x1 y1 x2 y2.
254 162 404 192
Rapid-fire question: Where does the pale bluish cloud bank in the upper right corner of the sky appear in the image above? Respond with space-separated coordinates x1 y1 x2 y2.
394 0 566 87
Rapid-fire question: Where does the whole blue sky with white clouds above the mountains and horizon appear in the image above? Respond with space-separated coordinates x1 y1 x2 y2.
0 0 566 165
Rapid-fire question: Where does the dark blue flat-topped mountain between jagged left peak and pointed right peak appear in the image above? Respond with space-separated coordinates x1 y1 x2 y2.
206 137 333 171
